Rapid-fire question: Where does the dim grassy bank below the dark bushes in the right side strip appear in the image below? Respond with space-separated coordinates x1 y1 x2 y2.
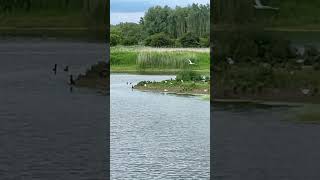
214 66 320 102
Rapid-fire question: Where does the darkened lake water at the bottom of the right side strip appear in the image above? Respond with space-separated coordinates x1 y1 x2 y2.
211 103 320 180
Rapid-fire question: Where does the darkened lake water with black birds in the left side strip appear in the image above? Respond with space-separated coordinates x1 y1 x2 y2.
0 39 109 180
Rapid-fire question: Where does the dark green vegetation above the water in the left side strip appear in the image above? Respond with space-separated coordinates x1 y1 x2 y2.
0 0 109 40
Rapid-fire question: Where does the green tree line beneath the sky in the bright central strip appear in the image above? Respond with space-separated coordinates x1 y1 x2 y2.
110 4 210 47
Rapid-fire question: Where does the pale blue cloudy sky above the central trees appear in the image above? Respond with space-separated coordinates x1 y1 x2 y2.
110 0 210 24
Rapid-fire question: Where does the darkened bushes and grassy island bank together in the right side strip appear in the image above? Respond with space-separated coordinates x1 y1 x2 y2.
213 29 320 102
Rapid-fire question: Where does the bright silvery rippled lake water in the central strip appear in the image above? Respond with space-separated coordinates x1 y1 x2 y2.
110 74 210 180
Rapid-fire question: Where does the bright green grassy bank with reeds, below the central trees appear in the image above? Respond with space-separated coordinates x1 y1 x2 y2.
110 46 210 74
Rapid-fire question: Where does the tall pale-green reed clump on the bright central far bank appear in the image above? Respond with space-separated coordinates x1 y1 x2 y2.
137 51 198 70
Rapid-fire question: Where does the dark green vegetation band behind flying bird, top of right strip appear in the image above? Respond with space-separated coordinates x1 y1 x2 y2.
213 0 320 26
